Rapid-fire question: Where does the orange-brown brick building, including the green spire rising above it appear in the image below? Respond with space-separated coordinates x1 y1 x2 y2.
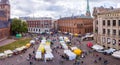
57 0 93 34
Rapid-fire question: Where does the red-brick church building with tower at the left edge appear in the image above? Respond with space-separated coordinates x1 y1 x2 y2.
0 0 10 41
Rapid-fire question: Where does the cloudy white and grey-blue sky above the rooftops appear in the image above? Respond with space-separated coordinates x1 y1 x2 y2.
10 0 120 19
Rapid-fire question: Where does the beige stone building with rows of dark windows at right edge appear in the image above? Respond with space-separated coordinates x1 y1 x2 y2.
93 7 120 50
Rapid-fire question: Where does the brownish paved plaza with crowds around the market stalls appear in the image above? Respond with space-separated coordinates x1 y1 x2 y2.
0 34 120 65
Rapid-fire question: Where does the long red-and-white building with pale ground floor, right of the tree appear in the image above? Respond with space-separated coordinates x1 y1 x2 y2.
20 17 53 33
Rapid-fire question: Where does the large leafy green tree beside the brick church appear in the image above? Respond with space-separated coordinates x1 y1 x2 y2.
11 18 28 34
